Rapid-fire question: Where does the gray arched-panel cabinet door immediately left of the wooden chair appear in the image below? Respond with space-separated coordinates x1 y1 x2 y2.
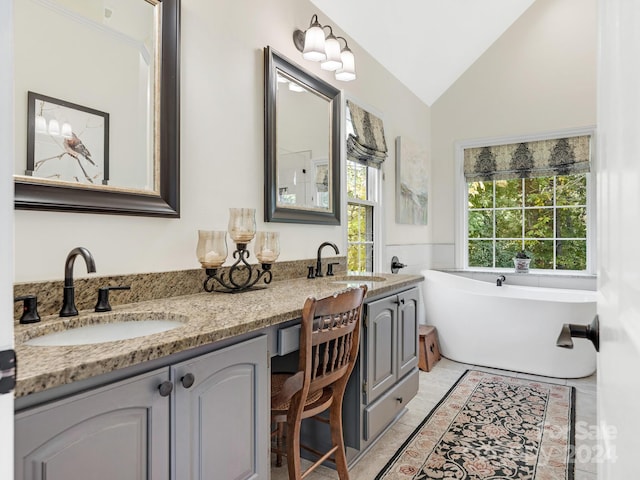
171 336 270 480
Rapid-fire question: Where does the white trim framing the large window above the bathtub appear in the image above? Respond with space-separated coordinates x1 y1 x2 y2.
455 126 597 276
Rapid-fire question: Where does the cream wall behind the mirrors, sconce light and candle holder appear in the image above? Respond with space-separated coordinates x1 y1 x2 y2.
15 0 430 282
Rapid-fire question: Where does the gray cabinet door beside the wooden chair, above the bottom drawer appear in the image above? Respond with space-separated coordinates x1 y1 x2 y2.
363 295 398 403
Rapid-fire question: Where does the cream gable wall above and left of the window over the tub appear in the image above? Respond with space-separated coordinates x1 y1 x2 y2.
430 0 597 267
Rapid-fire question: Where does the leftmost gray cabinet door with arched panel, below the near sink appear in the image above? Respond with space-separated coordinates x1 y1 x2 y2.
15 368 170 480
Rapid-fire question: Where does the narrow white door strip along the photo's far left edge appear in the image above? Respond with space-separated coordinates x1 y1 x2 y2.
0 0 13 478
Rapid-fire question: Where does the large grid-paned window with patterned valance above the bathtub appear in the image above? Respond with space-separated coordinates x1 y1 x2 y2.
458 129 595 273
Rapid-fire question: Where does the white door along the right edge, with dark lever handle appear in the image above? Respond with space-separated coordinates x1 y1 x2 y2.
596 0 640 480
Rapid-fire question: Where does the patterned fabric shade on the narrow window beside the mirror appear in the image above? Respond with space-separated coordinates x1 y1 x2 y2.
347 100 387 168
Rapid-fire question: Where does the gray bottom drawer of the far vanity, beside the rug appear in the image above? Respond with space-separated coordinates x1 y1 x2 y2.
364 368 418 441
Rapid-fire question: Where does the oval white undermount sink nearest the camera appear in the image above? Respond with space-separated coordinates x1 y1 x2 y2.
24 312 186 347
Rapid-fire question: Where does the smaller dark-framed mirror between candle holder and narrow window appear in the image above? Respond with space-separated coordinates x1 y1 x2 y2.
264 47 340 225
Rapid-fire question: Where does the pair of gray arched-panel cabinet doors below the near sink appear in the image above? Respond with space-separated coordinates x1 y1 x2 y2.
15 335 269 480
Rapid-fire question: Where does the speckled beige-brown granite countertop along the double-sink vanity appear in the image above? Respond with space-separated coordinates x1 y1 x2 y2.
15 273 423 397
